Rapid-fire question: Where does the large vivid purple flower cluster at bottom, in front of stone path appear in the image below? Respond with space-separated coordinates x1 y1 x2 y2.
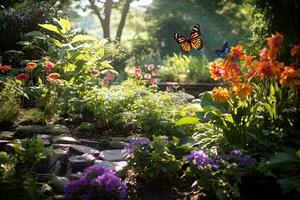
64 165 126 200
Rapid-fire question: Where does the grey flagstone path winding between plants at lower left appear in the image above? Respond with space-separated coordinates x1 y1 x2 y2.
0 125 128 199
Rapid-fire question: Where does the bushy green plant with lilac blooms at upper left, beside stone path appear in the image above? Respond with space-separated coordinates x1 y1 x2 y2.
123 136 181 181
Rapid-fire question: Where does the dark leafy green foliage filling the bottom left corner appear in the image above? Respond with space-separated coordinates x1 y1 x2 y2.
0 139 51 200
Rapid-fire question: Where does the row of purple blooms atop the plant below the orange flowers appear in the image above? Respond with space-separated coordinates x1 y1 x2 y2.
186 149 256 169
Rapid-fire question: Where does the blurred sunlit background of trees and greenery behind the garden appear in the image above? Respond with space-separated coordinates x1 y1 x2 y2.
0 0 300 82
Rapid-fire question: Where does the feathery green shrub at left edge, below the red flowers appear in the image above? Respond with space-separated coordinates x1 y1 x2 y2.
0 80 24 126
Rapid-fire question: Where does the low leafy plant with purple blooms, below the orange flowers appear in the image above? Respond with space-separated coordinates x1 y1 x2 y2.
186 149 255 199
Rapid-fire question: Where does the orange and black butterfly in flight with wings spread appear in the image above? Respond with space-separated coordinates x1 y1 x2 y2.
171 24 203 53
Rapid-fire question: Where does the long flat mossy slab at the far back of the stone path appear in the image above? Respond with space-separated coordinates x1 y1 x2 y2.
15 124 70 138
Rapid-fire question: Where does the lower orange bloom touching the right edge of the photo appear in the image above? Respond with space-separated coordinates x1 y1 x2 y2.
279 66 300 88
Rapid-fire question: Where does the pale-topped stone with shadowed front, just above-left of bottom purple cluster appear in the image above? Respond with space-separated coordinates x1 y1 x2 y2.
67 154 96 174
